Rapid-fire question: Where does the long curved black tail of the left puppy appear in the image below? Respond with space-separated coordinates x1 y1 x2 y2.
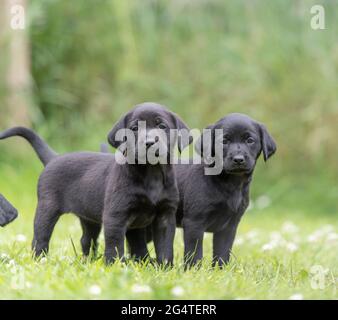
0 127 57 166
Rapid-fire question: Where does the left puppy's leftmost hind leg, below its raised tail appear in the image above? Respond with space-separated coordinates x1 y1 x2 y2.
32 200 60 257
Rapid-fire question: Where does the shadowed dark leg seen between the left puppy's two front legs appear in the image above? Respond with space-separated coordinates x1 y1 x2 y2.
126 228 149 261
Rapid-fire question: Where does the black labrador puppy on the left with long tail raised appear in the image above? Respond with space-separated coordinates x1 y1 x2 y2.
0 103 188 264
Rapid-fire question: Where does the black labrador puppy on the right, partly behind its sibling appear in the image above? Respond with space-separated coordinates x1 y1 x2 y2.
176 113 276 266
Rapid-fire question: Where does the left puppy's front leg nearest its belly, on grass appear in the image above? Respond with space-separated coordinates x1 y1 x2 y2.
103 214 127 264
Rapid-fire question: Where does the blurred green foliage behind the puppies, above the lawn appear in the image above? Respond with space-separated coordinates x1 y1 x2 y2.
0 0 338 215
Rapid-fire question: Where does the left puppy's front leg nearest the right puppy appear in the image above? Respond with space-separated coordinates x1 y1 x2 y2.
152 210 176 265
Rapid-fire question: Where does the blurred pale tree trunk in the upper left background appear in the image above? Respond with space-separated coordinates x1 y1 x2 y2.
0 0 32 126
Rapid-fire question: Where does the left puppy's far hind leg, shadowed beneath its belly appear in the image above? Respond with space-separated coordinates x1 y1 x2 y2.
80 218 101 257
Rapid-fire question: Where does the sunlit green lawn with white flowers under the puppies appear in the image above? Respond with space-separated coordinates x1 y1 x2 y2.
0 162 338 299
